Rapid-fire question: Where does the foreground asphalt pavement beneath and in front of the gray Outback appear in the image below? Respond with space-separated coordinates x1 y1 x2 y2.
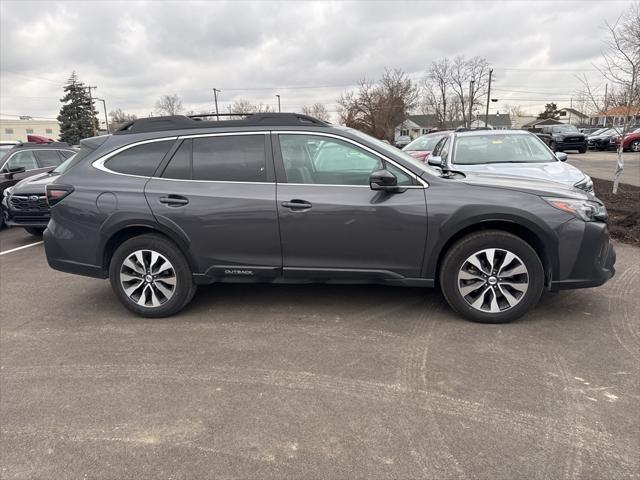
0 230 640 479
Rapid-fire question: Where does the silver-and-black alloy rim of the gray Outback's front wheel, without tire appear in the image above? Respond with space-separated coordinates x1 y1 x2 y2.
457 248 529 313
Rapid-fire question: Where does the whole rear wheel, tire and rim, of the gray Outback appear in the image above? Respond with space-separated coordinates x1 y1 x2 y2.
109 234 196 317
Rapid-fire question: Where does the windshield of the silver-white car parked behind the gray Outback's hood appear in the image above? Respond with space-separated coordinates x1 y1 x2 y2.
453 134 557 165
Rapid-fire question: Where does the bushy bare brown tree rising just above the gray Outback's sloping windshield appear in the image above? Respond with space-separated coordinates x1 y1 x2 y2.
338 69 419 142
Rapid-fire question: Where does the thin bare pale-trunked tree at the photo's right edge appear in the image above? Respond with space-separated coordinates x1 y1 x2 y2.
581 2 640 194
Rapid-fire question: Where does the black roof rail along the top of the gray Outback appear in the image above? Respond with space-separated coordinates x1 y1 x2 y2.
114 113 329 135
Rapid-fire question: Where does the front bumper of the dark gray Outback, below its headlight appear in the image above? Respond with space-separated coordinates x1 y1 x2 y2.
549 220 616 291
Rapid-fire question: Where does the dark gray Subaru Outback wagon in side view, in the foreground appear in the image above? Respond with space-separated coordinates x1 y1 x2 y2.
44 114 615 323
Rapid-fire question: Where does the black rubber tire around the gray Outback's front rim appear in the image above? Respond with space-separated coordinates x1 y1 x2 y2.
440 230 544 323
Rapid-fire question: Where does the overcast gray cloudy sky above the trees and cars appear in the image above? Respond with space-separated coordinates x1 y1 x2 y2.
0 0 631 122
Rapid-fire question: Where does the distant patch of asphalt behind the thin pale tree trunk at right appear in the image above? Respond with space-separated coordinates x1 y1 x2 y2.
567 150 640 187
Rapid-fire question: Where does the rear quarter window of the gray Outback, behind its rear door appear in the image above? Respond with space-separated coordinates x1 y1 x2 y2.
104 140 174 177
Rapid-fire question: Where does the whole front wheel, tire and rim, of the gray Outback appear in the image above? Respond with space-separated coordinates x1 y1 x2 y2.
440 230 544 323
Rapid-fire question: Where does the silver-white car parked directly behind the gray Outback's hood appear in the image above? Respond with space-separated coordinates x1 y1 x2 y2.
428 130 594 193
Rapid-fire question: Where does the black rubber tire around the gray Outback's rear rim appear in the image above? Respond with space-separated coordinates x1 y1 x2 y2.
109 234 196 318
